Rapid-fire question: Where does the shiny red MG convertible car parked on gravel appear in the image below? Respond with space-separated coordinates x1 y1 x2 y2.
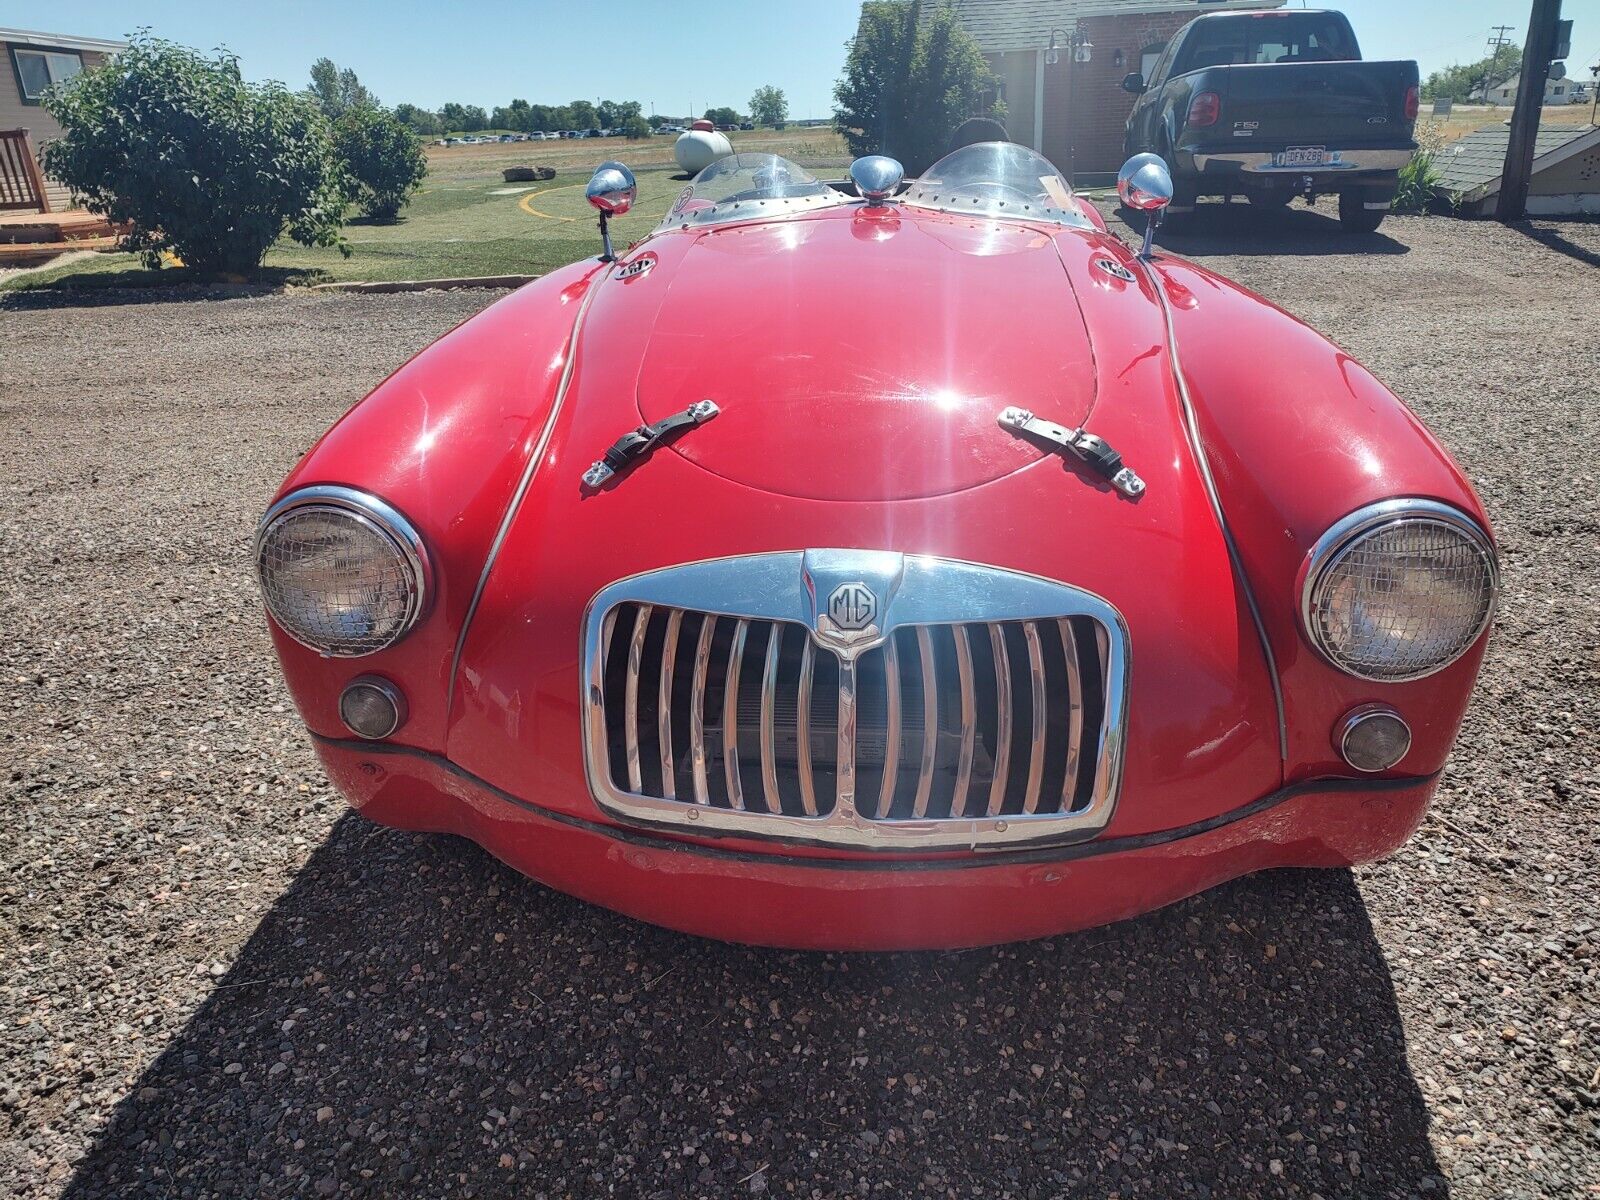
256 142 1496 949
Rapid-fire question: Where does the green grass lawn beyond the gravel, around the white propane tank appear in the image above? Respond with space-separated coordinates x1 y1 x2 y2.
0 130 845 291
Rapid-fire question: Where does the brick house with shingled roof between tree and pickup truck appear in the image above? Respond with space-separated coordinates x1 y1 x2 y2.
926 0 1283 184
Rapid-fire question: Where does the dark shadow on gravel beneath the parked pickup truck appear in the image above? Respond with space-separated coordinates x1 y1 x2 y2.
1117 200 1411 258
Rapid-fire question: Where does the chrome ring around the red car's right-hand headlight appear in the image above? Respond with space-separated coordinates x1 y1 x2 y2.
1299 499 1499 683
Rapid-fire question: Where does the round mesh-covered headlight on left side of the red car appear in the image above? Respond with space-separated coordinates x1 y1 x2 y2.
256 486 427 658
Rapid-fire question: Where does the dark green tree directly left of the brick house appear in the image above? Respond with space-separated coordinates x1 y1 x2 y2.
834 0 997 174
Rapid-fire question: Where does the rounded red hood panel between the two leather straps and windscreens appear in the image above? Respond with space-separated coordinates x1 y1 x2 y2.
624 210 1094 501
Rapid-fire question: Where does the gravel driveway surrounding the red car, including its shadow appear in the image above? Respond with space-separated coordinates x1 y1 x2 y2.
0 208 1600 1198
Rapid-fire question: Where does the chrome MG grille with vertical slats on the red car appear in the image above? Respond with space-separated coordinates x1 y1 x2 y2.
587 552 1125 846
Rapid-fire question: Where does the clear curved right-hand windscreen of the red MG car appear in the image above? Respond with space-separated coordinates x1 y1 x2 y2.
904 142 1090 229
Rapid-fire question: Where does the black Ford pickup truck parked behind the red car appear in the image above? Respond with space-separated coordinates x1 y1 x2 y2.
1122 8 1418 234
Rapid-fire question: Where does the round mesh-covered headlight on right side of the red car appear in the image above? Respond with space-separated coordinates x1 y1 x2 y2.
1301 501 1498 683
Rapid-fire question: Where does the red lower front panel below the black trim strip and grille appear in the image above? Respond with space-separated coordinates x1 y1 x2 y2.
317 738 1437 950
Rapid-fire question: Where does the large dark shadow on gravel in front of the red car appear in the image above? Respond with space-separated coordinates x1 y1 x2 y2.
64 816 1446 1200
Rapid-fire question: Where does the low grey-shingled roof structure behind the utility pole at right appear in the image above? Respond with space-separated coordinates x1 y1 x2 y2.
1434 125 1600 216
